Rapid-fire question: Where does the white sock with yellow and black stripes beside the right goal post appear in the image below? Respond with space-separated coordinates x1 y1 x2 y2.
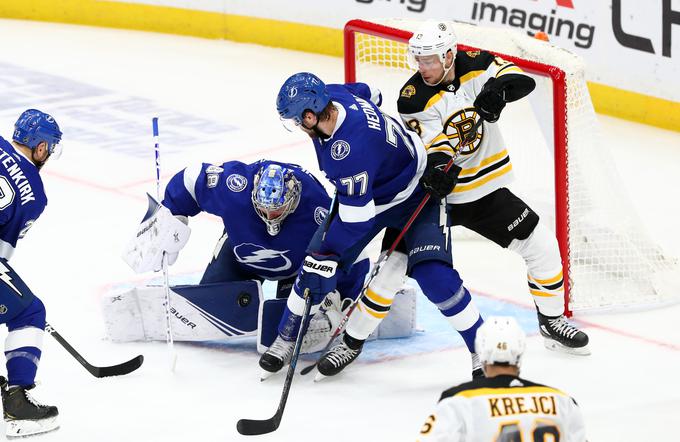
508 222 564 316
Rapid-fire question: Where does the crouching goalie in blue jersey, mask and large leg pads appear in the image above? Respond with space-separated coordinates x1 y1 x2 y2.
114 160 410 352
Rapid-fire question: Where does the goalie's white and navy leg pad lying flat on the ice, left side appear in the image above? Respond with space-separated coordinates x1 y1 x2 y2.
102 281 262 342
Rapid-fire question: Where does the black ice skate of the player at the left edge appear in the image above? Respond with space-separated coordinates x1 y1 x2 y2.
0 376 59 438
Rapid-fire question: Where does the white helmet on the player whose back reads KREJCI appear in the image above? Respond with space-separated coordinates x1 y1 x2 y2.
475 316 526 367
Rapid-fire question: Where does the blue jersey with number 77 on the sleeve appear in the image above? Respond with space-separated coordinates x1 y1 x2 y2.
314 83 427 256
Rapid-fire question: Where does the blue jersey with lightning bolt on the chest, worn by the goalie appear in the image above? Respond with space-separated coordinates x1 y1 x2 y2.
163 160 331 280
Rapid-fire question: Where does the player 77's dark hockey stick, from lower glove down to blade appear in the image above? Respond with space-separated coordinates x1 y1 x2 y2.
236 289 312 436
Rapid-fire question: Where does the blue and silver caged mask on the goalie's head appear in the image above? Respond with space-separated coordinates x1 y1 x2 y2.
252 164 302 236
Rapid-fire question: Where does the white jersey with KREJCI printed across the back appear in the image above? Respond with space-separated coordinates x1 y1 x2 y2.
418 375 586 442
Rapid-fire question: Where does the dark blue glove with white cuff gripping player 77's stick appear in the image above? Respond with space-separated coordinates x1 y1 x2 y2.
295 253 339 304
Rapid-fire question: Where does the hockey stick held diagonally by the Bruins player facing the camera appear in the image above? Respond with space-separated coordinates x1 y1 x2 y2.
300 118 484 375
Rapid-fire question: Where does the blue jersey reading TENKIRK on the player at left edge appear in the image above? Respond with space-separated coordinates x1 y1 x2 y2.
0 137 47 259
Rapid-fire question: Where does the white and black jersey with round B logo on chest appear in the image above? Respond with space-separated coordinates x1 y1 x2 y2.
397 51 522 203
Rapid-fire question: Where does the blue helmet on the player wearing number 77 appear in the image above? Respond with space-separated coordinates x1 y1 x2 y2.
276 72 331 125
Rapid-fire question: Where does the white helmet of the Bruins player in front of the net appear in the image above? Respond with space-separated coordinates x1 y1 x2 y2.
408 20 458 70
